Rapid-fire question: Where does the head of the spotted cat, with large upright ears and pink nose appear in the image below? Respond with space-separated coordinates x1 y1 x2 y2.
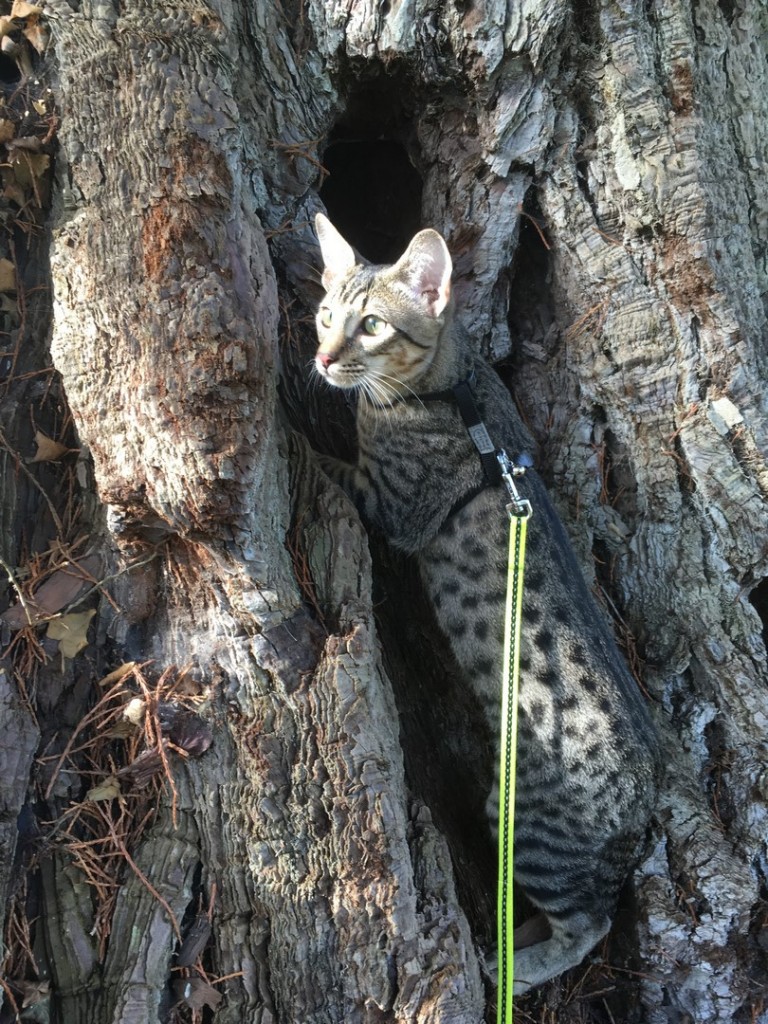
314 213 452 404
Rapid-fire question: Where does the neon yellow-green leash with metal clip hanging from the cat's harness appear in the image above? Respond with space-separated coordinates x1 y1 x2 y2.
497 452 531 1024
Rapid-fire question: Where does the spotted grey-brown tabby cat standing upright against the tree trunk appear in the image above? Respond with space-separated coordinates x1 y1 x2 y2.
314 214 657 994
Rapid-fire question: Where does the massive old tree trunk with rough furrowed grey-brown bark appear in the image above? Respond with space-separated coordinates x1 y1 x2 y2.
0 0 768 1024
